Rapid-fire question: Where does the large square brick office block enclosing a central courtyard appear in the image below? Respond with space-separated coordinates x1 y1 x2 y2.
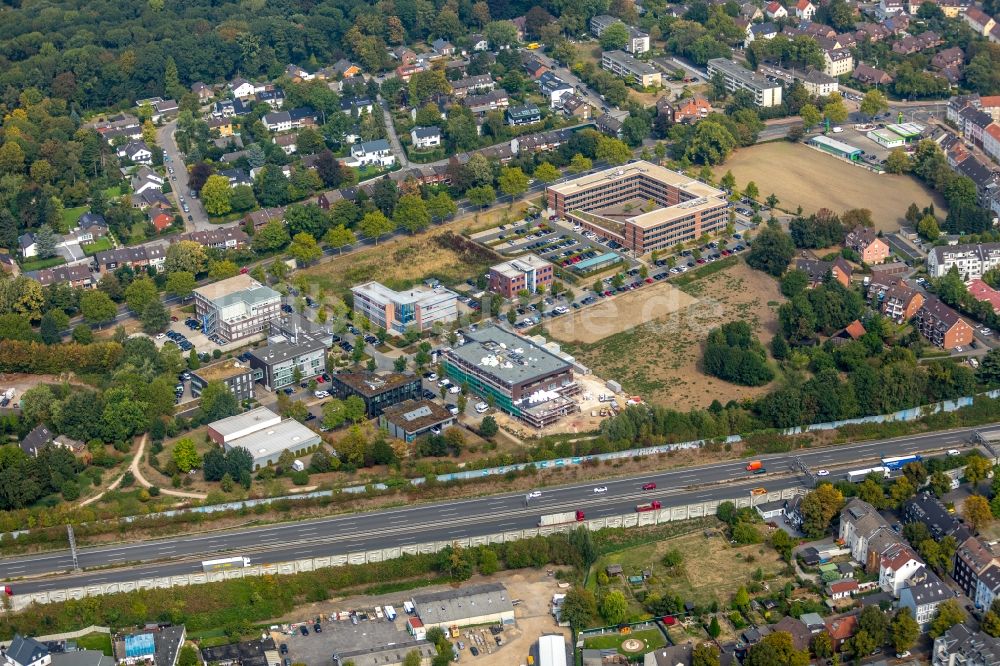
545 161 729 254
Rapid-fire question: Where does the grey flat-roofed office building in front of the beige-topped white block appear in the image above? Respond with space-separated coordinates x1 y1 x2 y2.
248 330 327 391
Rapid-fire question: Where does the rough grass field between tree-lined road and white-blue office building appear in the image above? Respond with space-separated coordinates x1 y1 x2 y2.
300 225 500 294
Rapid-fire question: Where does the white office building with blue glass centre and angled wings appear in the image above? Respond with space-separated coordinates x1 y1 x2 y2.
351 282 458 335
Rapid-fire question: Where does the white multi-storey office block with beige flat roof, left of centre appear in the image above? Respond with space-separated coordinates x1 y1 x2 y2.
194 275 281 342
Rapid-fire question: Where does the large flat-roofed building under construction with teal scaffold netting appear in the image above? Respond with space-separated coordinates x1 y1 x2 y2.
443 326 580 428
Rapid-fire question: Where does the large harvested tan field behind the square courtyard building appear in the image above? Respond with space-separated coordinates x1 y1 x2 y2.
715 141 946 231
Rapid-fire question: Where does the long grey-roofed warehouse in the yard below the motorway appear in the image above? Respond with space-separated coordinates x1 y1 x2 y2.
413 583 514 629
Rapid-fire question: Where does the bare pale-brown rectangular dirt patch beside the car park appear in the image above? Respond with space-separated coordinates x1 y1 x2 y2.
548 282 698 344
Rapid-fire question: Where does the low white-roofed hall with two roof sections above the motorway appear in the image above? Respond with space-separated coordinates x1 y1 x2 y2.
208 407 321 469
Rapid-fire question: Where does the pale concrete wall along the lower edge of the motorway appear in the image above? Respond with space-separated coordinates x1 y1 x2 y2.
10 487 808 608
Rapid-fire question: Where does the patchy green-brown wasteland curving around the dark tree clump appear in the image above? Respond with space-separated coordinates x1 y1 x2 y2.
551 260 785 410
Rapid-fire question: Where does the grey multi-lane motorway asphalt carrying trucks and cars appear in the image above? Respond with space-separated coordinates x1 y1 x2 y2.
0 429 973 594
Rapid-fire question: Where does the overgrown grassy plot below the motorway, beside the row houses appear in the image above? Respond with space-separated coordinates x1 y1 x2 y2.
591 528 785 611
